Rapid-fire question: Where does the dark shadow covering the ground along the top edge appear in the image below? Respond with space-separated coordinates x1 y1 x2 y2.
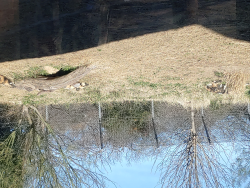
0 0 250 62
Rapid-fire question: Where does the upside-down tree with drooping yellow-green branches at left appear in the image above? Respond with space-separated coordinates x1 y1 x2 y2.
0 106 112 187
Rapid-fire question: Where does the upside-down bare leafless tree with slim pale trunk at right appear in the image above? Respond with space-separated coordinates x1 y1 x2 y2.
157 103 232 188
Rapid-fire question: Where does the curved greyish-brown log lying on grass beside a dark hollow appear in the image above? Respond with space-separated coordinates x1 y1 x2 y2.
15 67 95 94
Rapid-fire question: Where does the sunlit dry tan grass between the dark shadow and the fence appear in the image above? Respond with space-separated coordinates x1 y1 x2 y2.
0 25 250 106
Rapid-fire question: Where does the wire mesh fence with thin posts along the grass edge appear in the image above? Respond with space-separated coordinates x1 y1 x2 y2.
0 101 250 148
